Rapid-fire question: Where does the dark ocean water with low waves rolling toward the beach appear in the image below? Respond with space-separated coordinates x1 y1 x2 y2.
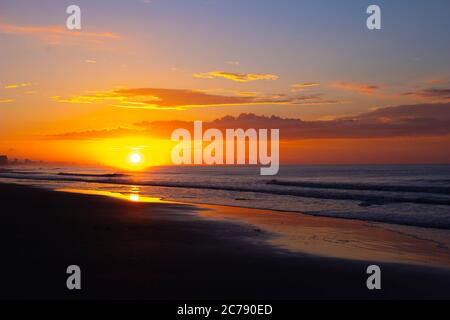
0 165 450 229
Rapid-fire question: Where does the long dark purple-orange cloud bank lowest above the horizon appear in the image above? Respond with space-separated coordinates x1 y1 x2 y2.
44 103 450 140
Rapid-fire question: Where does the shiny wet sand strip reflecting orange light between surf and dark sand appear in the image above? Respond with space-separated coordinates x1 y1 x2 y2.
54 185 450 269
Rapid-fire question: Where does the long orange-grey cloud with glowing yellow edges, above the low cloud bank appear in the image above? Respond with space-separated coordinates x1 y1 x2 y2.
51 88 340 110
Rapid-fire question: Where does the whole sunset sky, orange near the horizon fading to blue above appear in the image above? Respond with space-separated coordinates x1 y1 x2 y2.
0 0 450 166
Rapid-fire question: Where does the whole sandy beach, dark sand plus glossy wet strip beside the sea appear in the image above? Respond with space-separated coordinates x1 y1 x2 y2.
0 184 450 300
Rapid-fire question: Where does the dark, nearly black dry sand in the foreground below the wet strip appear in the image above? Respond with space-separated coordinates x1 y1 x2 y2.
0 184 450 300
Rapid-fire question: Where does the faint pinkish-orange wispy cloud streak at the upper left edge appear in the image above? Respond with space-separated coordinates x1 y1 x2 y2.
0 24 120 44
